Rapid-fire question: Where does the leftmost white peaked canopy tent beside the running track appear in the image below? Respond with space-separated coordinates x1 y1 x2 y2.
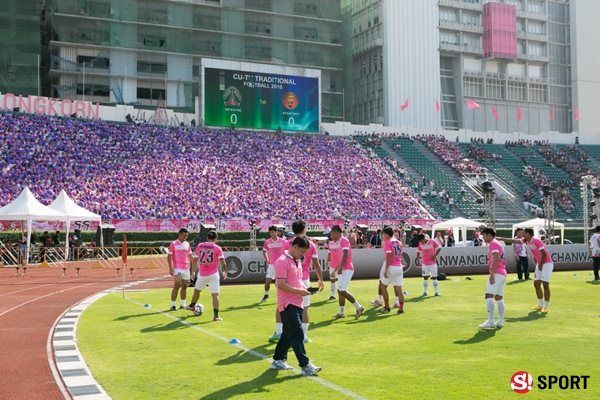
0 188 67 264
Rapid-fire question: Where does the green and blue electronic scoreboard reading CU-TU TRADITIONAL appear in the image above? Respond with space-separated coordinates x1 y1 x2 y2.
204 68 319 132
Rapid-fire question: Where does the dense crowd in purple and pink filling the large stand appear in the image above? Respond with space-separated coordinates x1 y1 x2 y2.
0 113 426 219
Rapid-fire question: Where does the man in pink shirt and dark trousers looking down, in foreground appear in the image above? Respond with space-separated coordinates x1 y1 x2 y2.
271 236 321 375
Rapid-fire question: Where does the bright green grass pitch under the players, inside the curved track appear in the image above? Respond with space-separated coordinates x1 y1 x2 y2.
77 271 600 400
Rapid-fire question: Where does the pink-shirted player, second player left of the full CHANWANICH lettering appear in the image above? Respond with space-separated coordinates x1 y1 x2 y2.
379 226 404 314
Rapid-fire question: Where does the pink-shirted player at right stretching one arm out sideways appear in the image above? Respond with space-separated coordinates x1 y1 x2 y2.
498 228 554 313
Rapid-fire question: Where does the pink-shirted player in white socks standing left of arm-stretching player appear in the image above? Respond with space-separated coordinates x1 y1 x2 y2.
479 228 506 329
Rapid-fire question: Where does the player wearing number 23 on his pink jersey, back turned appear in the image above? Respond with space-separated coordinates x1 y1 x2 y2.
187 231 227 321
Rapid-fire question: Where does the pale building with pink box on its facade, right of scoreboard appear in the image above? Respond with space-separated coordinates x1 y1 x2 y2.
343 0 584 134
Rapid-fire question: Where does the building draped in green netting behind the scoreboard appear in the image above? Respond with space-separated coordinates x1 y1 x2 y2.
44 0 344 122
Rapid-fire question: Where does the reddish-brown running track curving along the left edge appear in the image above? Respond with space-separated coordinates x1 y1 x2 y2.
0 268 172 400
